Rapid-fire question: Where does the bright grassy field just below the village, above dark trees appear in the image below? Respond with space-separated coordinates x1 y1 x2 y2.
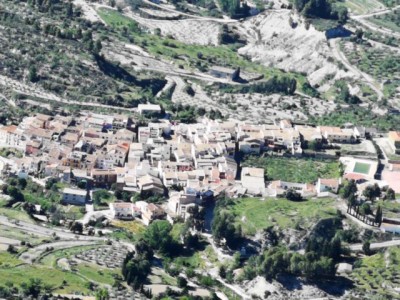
228 198 336 235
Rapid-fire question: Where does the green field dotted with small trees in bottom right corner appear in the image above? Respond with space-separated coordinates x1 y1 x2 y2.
351 248 400 299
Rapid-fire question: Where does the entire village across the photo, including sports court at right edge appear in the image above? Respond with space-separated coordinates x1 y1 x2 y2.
0 104 400 232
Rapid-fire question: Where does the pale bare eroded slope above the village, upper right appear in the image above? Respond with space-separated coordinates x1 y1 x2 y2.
239 10 347 84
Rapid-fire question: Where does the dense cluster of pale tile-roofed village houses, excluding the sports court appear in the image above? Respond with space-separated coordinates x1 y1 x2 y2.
0 105 400 223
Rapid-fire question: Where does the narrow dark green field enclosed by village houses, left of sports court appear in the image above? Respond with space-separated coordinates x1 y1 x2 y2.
243 156 341 183
